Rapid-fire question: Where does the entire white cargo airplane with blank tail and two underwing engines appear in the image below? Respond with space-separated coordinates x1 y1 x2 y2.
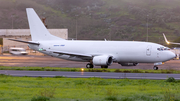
10 8 175 70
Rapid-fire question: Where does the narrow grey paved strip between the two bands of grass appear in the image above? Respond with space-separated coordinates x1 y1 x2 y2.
0 70 180 80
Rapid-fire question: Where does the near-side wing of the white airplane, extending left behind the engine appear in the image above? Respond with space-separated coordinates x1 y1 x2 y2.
51 50 93 59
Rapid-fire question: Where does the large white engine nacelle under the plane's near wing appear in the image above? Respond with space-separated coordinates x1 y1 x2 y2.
92 55 113 66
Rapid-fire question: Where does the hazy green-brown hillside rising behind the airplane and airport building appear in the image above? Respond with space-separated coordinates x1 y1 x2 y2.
0 0 180 44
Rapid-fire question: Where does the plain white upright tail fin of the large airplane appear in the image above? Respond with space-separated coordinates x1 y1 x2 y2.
26 8 64 41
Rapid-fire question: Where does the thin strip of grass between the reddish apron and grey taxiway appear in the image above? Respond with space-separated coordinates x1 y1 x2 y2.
0 66 180 74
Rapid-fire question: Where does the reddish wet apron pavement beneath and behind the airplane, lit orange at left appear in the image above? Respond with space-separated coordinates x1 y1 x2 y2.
0 55 180 70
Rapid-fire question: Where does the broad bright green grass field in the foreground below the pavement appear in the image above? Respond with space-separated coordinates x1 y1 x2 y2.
0 75 180 101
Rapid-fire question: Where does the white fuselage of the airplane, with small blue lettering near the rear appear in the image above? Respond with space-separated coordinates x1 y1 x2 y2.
29 41 175 63
